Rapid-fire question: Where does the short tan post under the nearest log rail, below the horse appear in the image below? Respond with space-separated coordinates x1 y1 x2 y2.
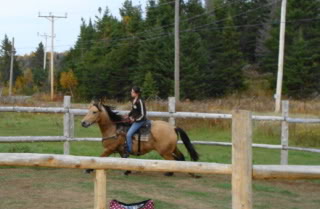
94 170 107 209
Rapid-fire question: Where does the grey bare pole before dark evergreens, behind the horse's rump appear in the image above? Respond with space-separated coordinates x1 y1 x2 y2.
174 0 180 103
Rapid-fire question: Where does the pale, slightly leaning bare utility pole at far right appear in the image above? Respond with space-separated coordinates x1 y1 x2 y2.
275 0 287 113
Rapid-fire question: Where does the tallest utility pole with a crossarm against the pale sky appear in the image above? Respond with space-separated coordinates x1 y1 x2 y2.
38 12 67 100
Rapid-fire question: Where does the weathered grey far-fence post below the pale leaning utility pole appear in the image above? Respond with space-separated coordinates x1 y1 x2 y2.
280 100 289 165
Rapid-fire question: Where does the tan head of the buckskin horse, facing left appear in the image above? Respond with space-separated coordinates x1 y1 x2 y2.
81 102 102 128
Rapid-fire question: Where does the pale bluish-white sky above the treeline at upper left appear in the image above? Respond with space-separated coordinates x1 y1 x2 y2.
0 0 146 55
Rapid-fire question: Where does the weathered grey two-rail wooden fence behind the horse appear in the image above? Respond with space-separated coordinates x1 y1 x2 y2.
0 96 320 165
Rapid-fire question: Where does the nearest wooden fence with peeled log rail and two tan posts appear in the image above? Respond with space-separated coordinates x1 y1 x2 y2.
0 111 320 209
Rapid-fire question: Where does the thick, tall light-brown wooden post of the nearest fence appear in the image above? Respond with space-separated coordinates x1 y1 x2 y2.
232 110 252 209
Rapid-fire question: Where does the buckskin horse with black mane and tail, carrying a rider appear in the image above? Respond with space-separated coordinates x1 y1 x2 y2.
81 102 199 176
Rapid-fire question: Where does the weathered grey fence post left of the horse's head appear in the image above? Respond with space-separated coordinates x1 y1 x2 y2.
63 96 74 155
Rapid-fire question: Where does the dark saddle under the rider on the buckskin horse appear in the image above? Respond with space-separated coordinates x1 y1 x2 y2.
117 120 151 141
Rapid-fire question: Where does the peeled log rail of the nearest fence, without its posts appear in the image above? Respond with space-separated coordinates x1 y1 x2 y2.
0 153 320 179
